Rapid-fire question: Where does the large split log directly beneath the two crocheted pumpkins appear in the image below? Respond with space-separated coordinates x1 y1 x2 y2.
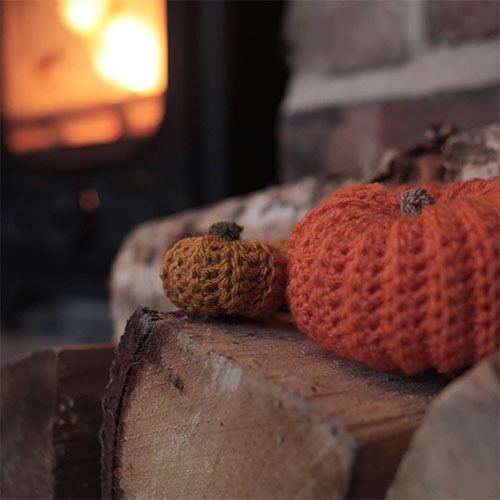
98 307 449 499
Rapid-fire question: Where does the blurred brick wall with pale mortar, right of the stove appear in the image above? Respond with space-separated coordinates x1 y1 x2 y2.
279 0 500 180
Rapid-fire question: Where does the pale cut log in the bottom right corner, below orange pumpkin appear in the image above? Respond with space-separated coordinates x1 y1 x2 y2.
388 352 500 499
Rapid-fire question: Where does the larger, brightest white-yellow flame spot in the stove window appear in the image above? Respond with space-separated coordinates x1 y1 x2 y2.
94 15 162 94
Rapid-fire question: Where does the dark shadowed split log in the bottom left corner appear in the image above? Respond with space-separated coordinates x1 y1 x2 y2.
0 344 114 499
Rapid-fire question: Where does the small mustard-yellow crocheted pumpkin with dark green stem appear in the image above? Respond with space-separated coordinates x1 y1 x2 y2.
160 222 286 317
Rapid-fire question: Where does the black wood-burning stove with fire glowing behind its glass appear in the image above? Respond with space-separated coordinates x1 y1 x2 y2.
1 0 286 350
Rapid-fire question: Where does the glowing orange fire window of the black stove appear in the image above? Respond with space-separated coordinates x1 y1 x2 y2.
2 0 168 152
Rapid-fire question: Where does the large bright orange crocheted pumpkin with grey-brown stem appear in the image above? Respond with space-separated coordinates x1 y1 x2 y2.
287 177 500 374
